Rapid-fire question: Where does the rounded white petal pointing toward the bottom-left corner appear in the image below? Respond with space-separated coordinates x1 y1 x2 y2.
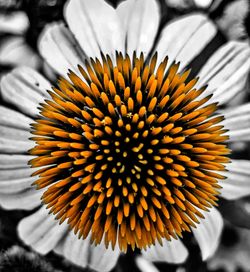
18 206 68 254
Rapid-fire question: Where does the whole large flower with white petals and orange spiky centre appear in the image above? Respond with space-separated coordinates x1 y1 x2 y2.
0 0 250 271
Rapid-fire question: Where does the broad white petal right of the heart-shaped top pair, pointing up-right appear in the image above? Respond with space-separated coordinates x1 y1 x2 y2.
155 14 217 68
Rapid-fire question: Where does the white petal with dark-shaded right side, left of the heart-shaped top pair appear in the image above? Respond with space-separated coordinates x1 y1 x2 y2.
38 23 85 77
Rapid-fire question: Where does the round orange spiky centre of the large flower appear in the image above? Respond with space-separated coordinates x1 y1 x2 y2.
30 53 229 252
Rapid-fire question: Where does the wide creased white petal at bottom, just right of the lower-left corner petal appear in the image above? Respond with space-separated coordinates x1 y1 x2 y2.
54 231 120 272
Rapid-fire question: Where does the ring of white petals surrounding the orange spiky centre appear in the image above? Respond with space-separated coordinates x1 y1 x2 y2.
0 0 250 271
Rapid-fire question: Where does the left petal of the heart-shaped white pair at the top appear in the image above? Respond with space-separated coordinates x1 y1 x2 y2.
65 0 125 58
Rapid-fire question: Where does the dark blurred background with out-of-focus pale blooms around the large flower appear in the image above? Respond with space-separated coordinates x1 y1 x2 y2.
0 0 250 272
